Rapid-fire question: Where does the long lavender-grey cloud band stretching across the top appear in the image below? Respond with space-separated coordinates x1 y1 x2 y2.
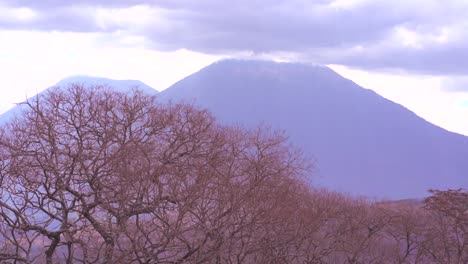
0 0 468 75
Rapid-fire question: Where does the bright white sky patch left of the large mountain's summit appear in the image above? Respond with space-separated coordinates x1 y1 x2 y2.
0 31 219 112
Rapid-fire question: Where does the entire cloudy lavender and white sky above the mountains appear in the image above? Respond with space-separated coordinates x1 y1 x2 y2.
0 0 468 135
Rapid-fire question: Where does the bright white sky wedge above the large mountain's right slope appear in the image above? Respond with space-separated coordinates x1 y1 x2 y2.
330 65 468 135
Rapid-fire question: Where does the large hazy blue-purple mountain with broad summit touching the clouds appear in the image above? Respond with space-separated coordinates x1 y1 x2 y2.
159 60 468 199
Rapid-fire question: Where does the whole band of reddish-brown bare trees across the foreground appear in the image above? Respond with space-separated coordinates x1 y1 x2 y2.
0 84 468 263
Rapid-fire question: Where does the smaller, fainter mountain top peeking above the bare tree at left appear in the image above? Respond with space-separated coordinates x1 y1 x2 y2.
0 76 158 125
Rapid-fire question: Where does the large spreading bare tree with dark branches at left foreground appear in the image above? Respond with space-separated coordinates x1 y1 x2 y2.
0 85 305 263
